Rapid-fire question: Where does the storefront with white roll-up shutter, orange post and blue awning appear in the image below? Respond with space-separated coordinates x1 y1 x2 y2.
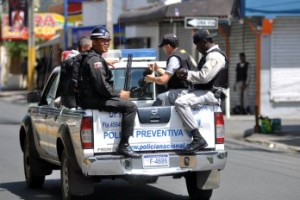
241 0 300 118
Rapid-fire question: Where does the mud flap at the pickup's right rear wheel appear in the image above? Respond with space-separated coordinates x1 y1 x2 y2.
197 170 220 190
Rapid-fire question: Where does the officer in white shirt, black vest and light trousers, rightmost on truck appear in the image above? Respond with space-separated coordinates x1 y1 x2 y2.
175 29 228 153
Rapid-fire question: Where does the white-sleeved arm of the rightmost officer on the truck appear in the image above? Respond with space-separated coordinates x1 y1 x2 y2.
187 52 226 84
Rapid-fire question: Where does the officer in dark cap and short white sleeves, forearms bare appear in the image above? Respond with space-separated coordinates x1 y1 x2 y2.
145 34 193 106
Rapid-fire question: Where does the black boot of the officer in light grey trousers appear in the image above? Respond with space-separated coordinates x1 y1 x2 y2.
183 129 207 154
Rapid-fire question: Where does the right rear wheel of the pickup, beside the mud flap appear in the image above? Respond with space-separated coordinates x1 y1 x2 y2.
185 172 213 200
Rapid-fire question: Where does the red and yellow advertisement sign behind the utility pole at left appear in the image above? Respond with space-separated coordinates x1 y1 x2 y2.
2 13 64 40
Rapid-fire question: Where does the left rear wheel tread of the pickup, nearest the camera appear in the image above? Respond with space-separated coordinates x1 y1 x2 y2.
60 150 74 200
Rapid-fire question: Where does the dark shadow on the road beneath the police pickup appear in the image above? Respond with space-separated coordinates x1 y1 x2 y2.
0 179 189 200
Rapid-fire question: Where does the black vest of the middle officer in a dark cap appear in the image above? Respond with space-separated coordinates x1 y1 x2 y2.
167 49 192 89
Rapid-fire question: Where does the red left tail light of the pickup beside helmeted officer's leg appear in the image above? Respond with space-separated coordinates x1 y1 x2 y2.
80 117 93 149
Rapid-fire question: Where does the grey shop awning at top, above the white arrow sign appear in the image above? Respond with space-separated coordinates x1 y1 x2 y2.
119 0 239 24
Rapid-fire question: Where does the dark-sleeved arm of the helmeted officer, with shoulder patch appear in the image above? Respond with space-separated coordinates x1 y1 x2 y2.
88 57 120 98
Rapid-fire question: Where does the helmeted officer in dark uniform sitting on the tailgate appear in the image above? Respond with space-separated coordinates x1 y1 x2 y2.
80 26 140 157
